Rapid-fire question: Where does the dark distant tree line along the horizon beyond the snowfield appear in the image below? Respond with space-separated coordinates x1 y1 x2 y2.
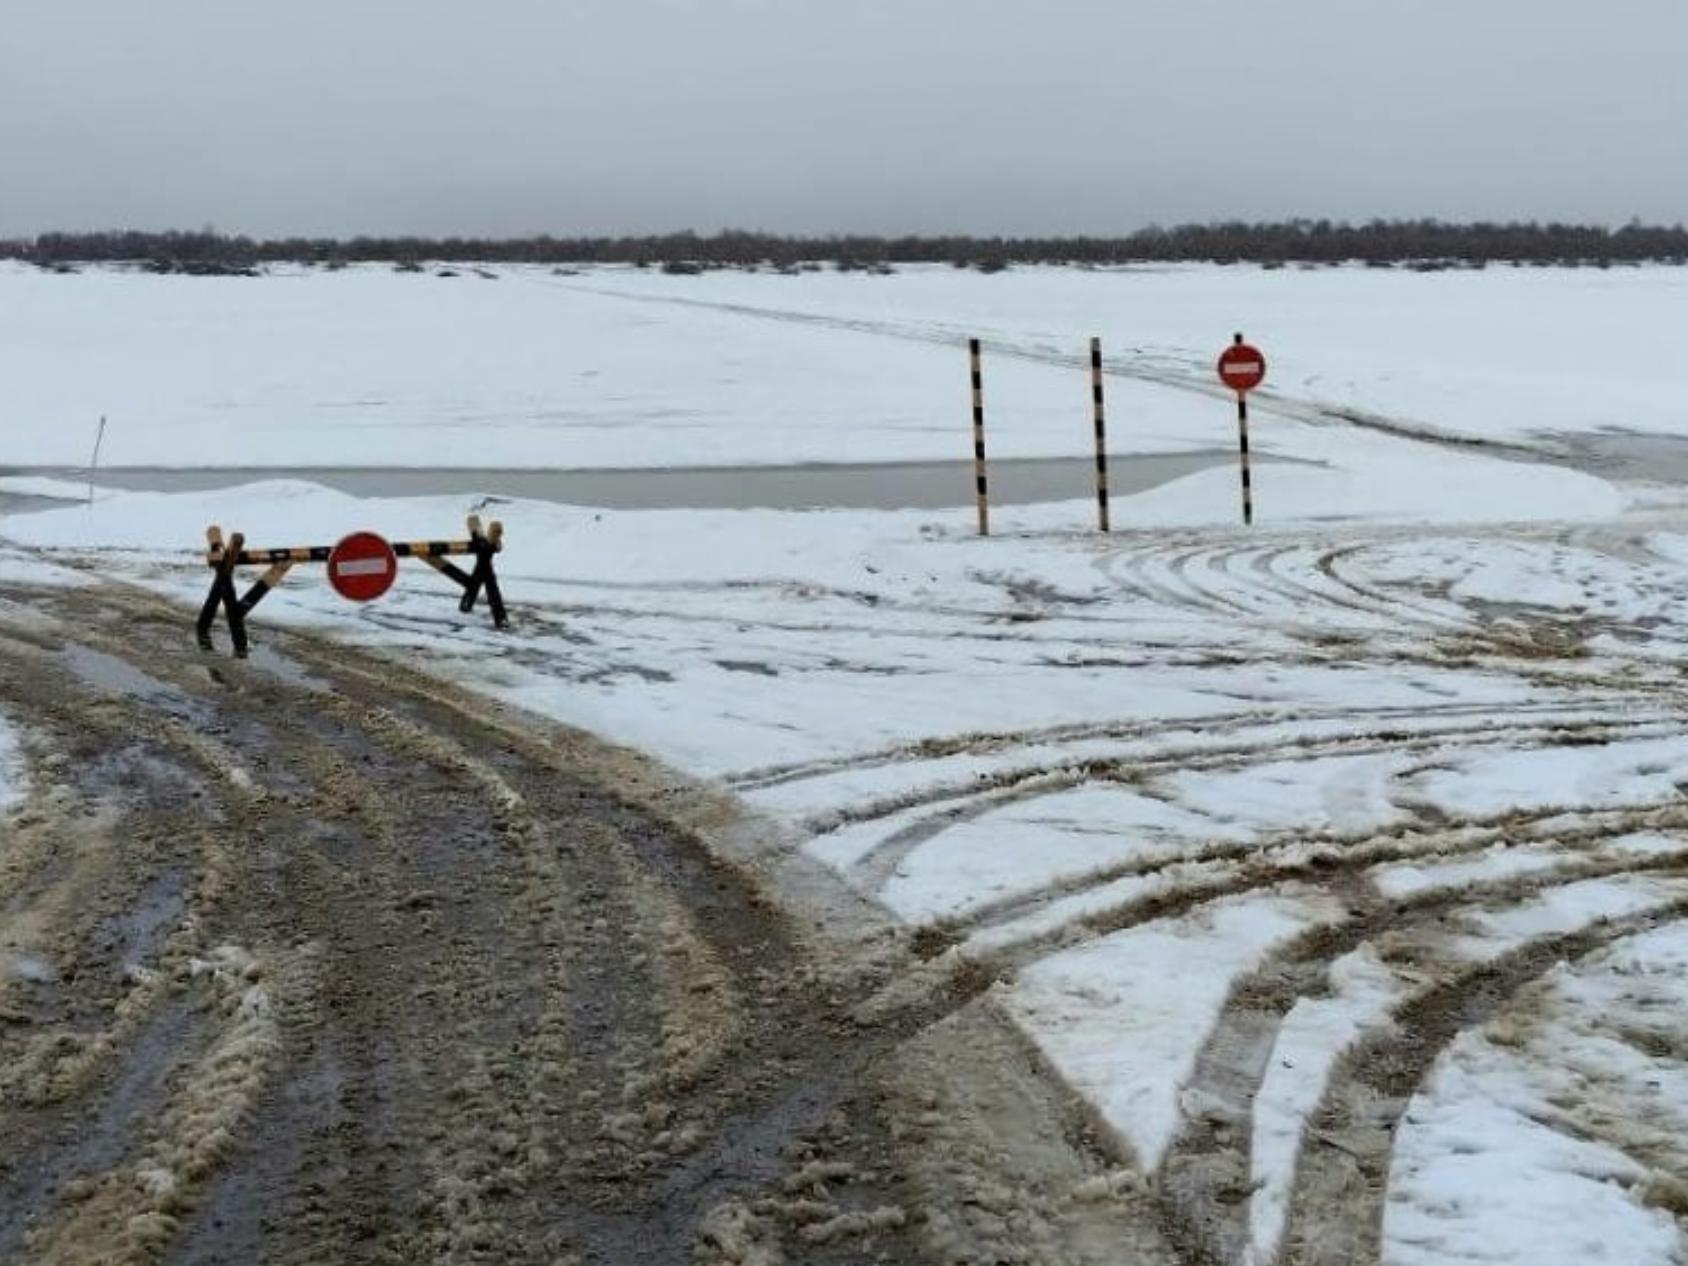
0 219 1688 273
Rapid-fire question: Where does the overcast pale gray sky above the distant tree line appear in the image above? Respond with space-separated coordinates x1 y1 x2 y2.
0 0 1688 235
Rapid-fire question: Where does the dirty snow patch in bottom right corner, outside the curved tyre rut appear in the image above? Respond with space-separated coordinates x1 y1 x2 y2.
1382 923 1688 1266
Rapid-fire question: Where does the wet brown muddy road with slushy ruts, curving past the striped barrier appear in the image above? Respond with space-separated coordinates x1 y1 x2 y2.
0 587 1163 1266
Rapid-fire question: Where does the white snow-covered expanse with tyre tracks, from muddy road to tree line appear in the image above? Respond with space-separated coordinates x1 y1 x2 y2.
0 259 1688 1266
